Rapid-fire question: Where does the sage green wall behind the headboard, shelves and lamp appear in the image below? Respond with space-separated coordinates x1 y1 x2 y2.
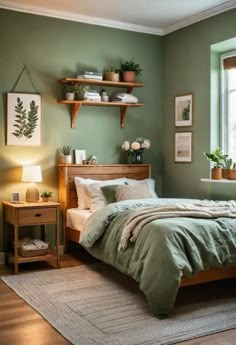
0 10 163 252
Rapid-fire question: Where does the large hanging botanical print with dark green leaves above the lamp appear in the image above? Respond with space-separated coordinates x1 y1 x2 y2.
7 93 41 146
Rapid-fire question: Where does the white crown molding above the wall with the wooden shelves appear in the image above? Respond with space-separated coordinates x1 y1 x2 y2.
0 0 162 35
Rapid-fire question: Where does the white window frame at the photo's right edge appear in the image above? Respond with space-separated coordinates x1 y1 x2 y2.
220 50 236 154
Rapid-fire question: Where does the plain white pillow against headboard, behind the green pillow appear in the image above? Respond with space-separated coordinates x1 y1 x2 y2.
75 176 126 210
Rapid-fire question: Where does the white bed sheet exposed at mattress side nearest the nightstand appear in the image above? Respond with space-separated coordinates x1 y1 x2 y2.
66 208 92 232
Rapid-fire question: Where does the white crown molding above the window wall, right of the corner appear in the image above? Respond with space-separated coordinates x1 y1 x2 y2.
161 0 236 36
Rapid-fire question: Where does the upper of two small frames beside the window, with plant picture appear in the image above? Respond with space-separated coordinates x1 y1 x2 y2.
175 93 193 127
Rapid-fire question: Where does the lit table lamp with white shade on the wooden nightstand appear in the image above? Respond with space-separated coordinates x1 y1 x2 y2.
21 165 42 202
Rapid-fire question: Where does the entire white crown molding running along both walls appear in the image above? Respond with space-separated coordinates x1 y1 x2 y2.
0 0 236 36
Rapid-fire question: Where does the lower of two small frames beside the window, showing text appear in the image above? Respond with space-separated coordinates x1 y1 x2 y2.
175 132 193 163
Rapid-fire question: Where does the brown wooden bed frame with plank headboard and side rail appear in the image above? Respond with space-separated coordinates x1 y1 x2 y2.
58 164 236 286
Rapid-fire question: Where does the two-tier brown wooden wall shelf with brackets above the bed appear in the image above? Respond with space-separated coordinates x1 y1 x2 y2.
58 78 144 128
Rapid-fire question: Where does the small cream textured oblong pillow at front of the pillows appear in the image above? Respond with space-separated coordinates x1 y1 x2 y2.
116 182 152 201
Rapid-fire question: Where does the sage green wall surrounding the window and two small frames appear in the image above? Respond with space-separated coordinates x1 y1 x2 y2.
162 10 236 199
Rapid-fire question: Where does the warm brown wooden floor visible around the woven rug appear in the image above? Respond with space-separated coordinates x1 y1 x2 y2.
0 245 236 345
